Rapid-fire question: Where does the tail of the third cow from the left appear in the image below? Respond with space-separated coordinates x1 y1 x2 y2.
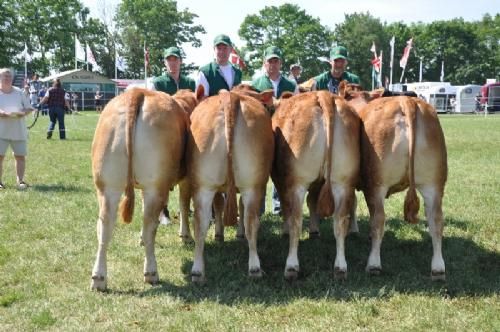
317 93 337 218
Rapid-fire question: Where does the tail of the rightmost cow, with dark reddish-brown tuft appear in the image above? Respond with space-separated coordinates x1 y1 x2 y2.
401 97 420 224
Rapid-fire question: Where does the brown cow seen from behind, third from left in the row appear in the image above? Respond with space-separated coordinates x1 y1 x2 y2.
272 91 360 279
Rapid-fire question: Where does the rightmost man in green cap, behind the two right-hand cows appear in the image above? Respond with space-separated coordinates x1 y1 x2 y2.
311 46 359 94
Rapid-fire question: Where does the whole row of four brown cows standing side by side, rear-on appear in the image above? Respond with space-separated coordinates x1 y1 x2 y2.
91 83 447 290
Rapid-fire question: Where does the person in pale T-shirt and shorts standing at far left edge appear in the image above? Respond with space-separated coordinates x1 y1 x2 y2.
0 68 34 190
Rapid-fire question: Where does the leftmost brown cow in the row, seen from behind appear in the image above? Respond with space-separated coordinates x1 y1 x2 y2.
91 88 203 290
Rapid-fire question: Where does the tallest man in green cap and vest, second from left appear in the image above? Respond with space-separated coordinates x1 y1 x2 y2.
196 35 241 96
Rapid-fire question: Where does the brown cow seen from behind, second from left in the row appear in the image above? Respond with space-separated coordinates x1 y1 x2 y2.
187 90 274 282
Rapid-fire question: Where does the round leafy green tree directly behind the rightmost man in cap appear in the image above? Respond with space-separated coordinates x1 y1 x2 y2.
334 12 392 89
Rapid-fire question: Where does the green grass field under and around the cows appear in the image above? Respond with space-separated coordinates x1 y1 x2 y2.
0 112 500 331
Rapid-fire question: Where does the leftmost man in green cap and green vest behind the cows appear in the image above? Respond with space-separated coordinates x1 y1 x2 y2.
153 47 195 95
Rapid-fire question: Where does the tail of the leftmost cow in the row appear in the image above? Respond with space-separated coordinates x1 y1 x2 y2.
119 90 144 224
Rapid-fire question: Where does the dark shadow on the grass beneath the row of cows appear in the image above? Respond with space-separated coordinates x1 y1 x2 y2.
109 215 500 305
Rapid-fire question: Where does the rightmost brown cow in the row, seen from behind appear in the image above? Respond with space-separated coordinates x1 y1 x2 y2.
339 84 448 280
